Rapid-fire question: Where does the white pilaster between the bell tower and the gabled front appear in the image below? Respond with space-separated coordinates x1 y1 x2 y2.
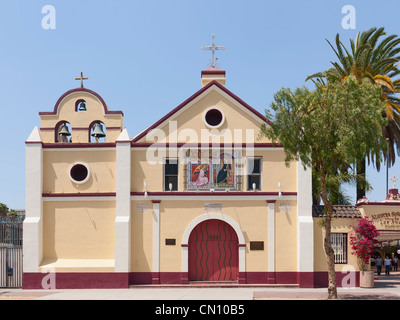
115 129 131 273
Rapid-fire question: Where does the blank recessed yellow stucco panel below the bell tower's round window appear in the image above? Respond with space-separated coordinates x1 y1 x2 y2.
43 201 115 260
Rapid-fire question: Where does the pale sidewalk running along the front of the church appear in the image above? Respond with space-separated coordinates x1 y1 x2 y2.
0 272 400 300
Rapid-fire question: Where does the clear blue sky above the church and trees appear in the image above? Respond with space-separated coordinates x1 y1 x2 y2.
0 0 400 209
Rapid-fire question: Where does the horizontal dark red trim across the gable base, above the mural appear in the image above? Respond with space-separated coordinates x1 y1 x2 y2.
132 141 283 149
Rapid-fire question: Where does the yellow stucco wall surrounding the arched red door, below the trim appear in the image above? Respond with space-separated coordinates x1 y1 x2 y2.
132 200 297 272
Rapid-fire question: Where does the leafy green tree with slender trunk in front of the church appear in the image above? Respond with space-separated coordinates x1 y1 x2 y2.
261 76 387 299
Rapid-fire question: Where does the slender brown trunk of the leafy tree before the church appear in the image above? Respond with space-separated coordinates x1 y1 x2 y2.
320 174 337 299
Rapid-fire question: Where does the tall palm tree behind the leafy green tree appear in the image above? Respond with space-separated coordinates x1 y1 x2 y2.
306 28 400 200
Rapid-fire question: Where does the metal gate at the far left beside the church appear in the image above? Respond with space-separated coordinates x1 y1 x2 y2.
0 219 22 288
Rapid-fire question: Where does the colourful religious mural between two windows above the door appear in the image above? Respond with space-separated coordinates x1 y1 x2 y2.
185 150 241 191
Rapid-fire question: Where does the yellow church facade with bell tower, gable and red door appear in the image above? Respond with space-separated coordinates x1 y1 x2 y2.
23 67 400 288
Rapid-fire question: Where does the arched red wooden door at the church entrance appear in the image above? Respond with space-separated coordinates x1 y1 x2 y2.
189 219 238 281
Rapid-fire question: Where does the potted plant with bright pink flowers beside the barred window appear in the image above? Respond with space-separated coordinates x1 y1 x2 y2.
350 217 380 288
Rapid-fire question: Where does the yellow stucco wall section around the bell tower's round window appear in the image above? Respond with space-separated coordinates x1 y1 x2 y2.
43 149 116 193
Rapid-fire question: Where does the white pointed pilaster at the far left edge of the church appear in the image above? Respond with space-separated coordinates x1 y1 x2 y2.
23 127 43 273
